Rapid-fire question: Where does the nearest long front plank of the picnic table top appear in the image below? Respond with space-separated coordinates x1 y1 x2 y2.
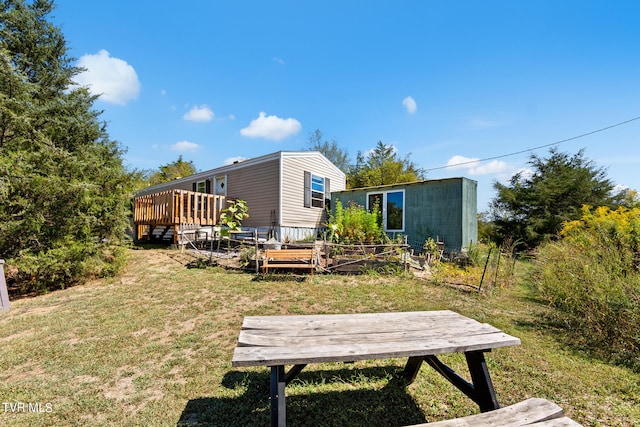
231 332 520 367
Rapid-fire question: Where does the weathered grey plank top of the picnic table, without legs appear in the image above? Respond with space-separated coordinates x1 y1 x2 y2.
231 310 520 367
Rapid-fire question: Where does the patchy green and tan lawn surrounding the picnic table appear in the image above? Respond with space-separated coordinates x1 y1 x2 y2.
0 249 640 426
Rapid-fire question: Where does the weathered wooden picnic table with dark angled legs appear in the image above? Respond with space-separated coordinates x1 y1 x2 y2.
231 310 520 426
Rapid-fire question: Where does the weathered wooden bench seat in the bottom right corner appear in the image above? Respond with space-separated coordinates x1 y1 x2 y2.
413 397 580 427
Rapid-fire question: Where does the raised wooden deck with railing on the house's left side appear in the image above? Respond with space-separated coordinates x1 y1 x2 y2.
133 190 226 243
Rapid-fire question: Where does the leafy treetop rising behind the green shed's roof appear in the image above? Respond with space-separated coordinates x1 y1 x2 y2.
347 141 425 188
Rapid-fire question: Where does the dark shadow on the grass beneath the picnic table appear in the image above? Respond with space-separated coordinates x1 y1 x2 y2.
177 367 425 427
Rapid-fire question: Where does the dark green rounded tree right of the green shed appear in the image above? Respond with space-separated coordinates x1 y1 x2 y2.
491 148 620 248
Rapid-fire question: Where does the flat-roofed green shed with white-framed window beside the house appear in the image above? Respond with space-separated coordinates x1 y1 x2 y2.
331 178 478 252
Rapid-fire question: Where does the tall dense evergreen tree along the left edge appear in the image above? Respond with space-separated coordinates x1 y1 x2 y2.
0 0 137 291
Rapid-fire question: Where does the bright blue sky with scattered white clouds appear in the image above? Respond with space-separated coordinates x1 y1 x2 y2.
52 0 640 211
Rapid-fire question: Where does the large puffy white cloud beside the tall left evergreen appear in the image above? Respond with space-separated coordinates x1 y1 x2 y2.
74 49 140 105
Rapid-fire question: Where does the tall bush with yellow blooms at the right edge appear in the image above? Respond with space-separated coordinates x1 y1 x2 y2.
537 207 640 368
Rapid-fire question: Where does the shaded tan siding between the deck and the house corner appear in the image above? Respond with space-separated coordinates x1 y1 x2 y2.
226 158 280 227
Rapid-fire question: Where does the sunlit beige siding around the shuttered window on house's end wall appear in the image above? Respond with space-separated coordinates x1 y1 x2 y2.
281 152 345 227
